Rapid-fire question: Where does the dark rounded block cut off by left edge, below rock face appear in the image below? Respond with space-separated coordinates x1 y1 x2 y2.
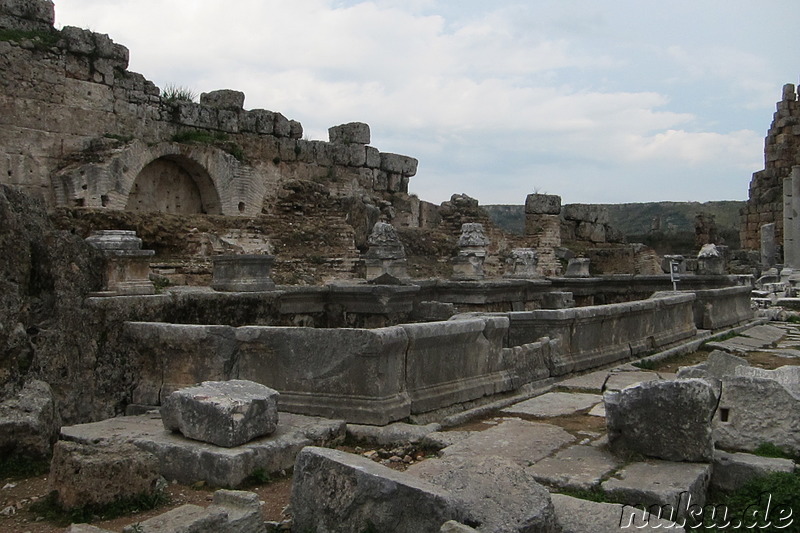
0 380 60 459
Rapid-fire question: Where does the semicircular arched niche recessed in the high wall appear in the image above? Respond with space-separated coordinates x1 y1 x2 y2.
125 154 222 215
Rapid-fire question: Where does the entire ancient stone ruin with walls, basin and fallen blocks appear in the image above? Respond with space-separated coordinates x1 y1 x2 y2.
0 0 800 533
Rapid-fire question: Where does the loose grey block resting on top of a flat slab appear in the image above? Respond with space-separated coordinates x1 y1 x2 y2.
160 380 279 448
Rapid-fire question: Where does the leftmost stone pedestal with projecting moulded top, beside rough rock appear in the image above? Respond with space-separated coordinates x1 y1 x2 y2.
86 230 156 296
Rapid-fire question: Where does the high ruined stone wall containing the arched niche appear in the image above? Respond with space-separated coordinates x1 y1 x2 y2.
0 0 419 226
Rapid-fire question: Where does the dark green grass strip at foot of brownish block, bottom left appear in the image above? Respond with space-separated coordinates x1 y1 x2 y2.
30 490 169 527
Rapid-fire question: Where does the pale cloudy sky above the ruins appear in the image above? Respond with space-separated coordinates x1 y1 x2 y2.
55 0 800 204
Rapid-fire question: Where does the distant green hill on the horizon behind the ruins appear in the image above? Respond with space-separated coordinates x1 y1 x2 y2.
482 201 745 236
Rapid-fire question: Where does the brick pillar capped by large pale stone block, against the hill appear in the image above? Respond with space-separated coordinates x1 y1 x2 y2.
525 194 561 276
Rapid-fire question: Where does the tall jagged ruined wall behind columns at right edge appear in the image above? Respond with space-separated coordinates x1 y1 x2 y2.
740 84 800 250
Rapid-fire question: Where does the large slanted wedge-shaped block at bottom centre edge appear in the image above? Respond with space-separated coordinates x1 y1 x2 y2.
291 446 465 533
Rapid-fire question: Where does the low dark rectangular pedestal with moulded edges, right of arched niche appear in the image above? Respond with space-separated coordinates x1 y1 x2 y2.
211 254 275 292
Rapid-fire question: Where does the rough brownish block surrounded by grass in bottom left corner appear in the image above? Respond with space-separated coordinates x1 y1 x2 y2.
50 440 161 509
